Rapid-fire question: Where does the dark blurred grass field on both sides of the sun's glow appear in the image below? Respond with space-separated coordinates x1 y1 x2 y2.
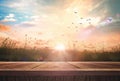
0 38 120 61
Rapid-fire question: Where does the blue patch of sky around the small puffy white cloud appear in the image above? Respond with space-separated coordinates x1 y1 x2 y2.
0 0 32 25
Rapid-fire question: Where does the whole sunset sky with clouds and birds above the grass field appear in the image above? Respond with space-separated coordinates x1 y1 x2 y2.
0 0 120 49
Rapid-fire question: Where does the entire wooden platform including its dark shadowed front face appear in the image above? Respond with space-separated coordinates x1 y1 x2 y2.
0 62 120 81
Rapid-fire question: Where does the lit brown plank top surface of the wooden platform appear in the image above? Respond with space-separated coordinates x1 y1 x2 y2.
0 62 120 71
